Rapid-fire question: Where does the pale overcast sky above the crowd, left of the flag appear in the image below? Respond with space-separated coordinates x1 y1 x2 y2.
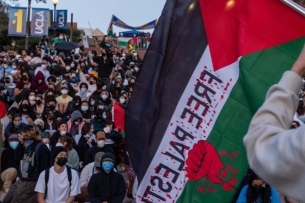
19 0 166 33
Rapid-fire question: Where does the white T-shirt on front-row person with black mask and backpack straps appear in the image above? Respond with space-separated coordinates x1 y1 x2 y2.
35 166 80 203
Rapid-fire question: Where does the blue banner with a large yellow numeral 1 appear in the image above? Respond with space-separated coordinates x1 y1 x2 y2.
8 7 27 37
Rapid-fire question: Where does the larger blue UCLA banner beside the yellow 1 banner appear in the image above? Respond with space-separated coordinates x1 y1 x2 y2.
31 8 49 37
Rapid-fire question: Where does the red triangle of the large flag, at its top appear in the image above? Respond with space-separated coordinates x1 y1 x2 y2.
199 0 305 71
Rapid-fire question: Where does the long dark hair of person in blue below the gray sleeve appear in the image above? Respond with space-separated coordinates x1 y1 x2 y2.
246 172 271 203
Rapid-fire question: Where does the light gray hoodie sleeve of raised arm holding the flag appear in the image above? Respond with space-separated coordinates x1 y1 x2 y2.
244 71 305 202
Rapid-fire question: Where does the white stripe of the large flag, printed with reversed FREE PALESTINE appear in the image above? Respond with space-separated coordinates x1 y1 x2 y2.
137 47 239 202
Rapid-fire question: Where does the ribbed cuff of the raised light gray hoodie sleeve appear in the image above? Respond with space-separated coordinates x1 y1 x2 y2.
279 71 304 94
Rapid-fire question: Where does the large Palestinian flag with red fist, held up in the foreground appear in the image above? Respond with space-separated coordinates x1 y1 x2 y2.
126 0 305 203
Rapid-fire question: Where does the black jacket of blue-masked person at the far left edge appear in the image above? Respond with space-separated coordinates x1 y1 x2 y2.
1 147 20 172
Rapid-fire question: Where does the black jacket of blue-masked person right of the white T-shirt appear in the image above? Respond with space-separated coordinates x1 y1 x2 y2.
88 169 126 203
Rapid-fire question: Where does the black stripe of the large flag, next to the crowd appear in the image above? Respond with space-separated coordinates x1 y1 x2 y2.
126 0 207 184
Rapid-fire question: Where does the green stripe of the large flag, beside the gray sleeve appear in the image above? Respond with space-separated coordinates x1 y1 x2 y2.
177 37 305 203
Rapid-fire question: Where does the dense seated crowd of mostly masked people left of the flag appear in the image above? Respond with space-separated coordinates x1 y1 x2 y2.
0 33 142 203
